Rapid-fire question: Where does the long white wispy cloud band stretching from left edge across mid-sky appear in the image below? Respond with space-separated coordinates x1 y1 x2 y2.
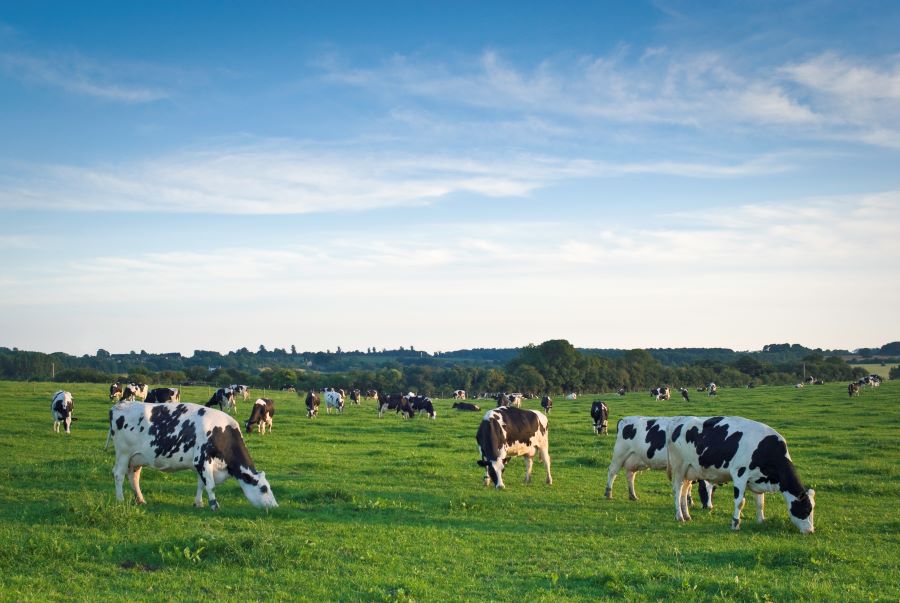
0 141 790 214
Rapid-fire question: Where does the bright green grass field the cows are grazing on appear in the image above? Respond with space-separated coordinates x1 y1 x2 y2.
0 382 900 602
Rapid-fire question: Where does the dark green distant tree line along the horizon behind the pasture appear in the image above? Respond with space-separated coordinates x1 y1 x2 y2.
0 339 884 395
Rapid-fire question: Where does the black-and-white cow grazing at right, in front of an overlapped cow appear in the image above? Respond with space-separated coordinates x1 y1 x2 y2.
668 417 816 534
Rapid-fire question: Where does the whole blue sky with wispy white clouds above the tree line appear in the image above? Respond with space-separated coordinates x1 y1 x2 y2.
0 1 900 354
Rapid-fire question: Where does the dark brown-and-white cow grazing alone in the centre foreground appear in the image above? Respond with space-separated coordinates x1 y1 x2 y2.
475 406 553 488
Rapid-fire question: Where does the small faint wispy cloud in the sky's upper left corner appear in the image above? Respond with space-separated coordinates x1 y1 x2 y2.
0 52 170 103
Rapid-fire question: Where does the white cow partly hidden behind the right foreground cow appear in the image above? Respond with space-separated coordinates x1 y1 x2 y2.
604 416 713 509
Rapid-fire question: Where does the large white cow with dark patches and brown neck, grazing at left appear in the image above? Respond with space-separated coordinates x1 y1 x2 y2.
107 402 278 511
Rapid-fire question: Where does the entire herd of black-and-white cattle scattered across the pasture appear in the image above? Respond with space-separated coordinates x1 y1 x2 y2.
50 375 882 533
